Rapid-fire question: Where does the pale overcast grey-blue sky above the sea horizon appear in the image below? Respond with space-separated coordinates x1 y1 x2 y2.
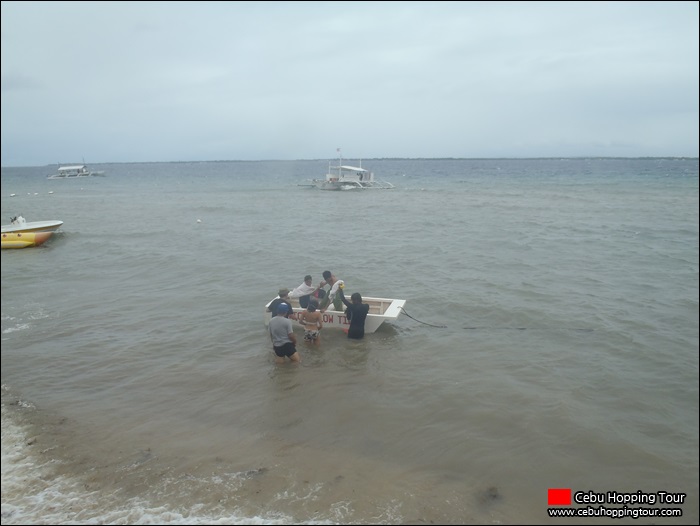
1 1 699 166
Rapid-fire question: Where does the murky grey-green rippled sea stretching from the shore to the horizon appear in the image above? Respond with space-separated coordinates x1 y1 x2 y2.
2 159 699 524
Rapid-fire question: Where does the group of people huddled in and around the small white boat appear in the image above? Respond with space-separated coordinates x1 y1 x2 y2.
267 270 369 363
